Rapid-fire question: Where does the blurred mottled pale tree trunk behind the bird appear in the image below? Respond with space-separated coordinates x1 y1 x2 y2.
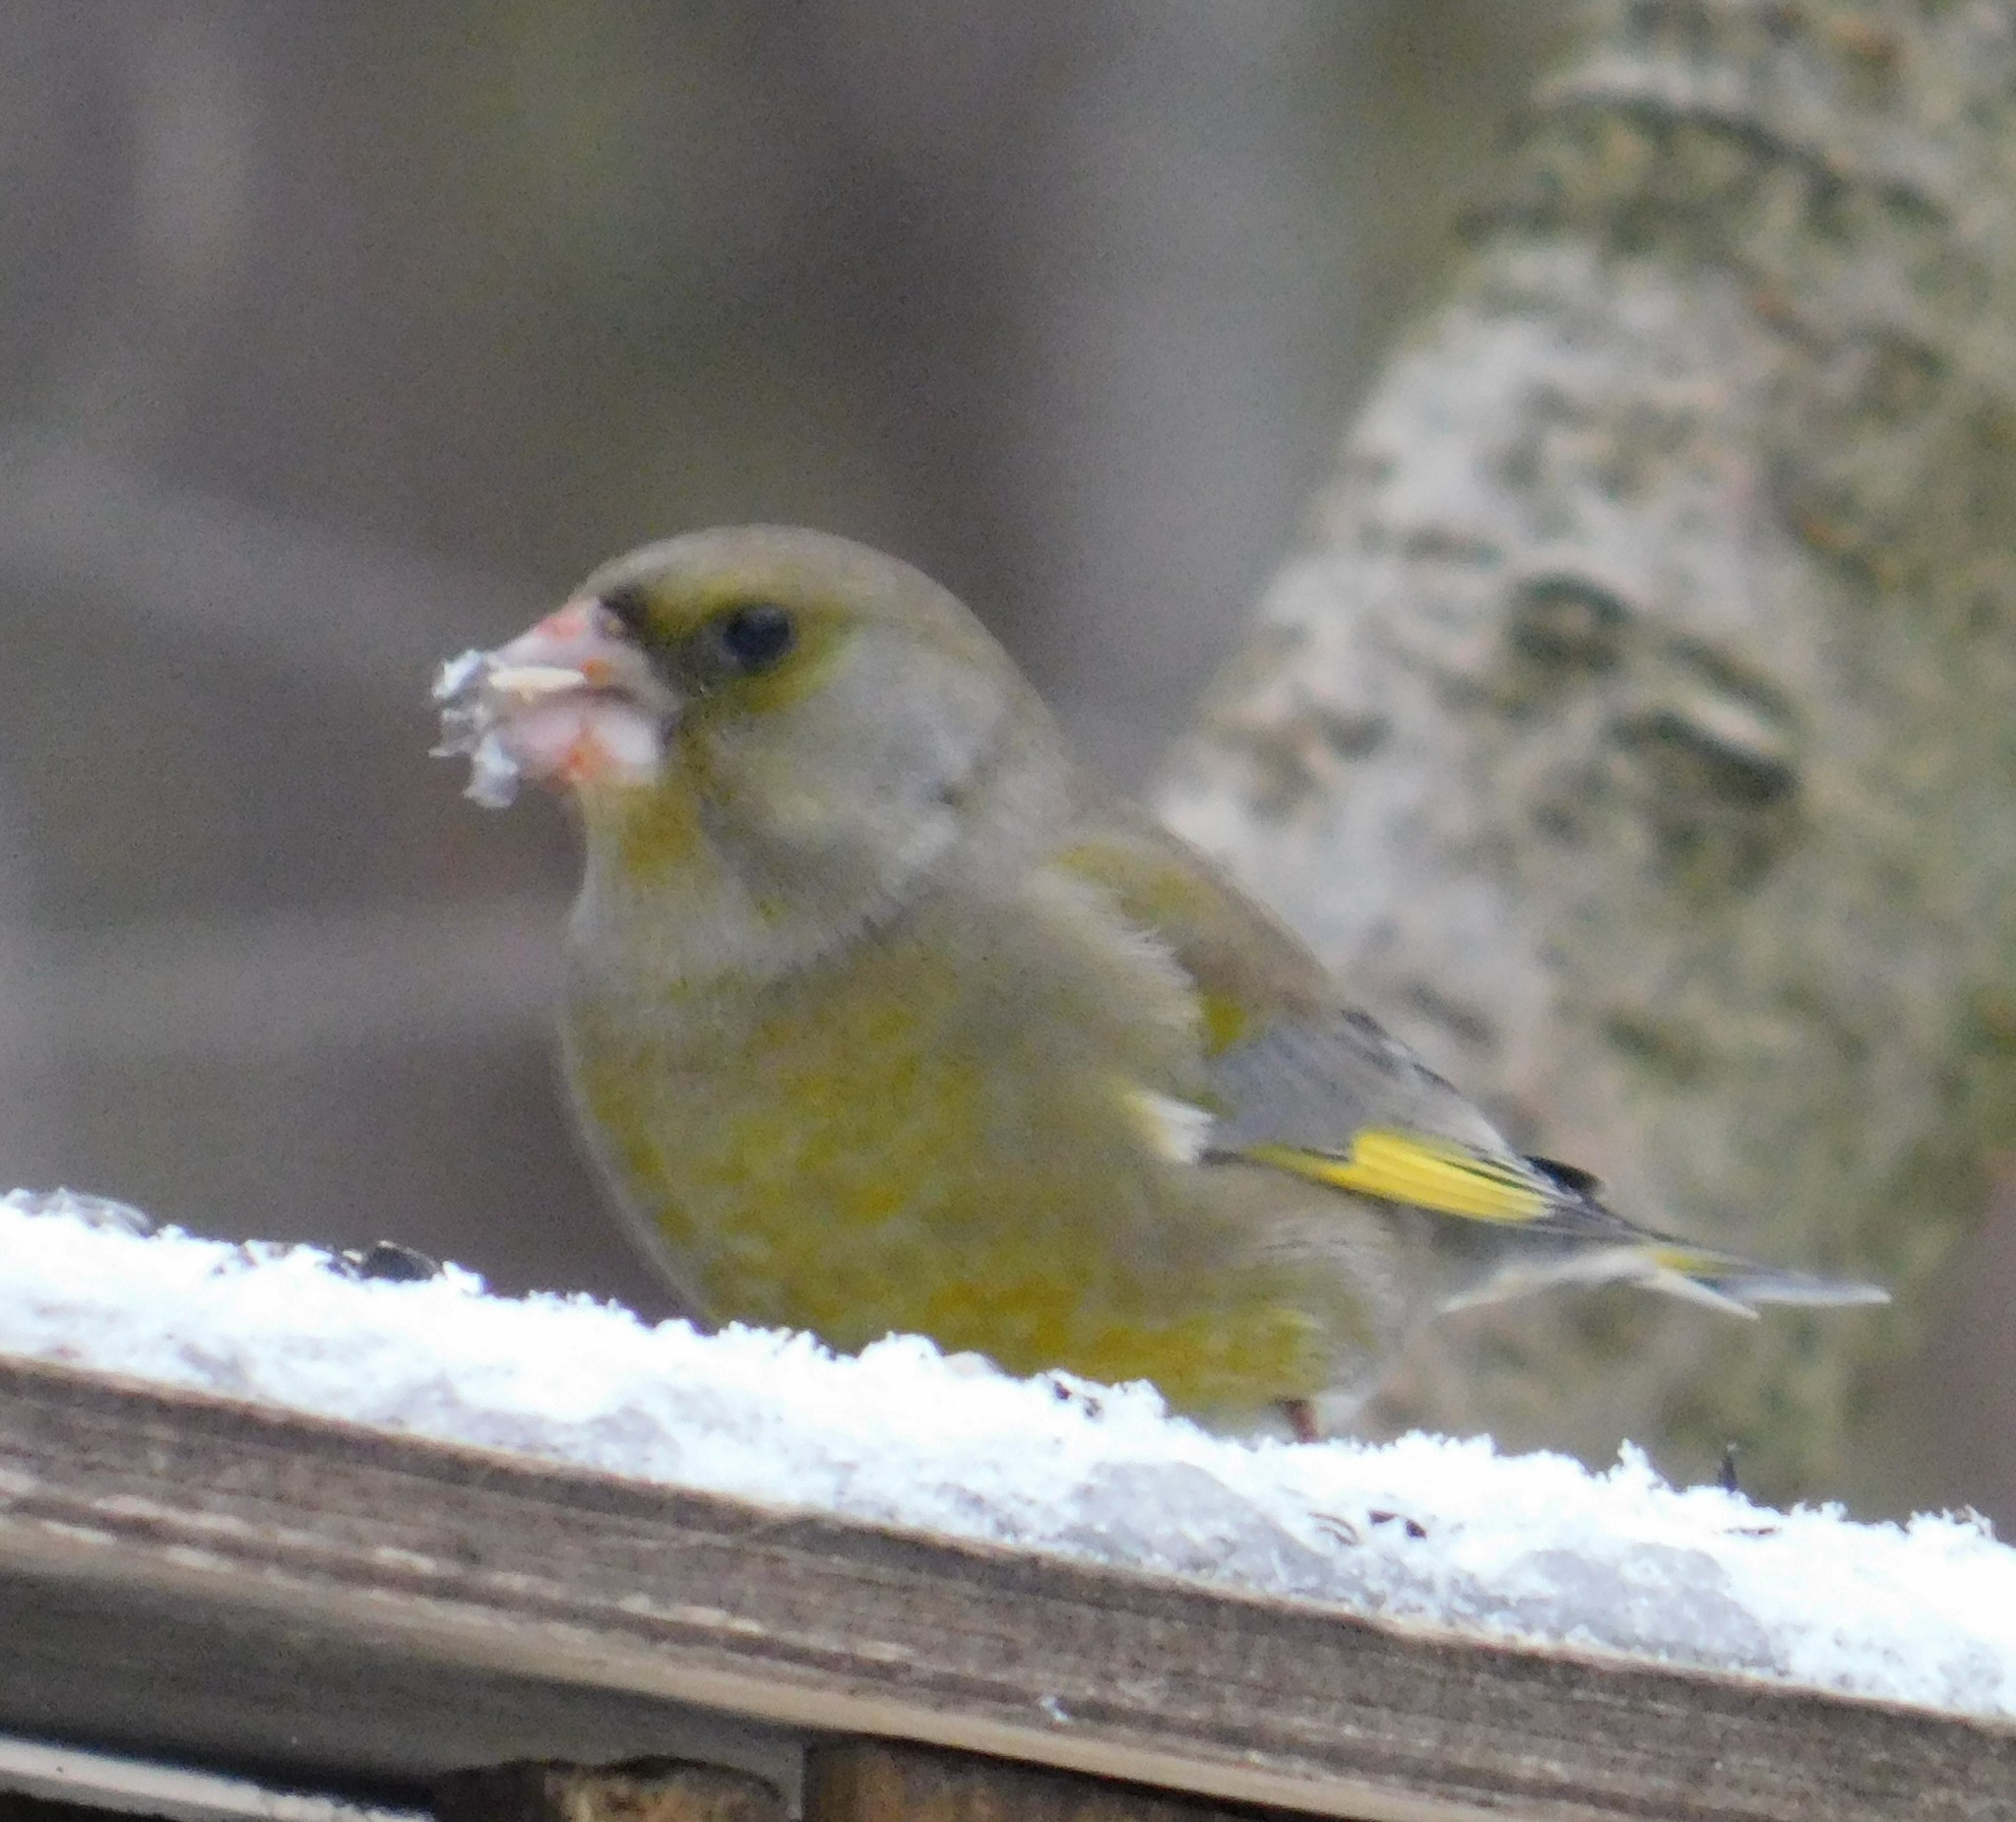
1164 0 2016 1499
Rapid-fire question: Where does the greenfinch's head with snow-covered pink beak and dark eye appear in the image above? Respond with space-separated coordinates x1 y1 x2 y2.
437 526 1064 975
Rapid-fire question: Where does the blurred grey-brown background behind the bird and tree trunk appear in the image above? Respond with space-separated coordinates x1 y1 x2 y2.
0 0 2016 1510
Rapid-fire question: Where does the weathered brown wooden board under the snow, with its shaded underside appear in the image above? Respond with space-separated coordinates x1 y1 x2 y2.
0 1362 2016 1822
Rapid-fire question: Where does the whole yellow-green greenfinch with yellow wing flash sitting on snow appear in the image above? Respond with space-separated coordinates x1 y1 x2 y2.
435 526 1883 1435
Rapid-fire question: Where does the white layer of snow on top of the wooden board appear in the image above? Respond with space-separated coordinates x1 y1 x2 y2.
0 1191 2016 1718
